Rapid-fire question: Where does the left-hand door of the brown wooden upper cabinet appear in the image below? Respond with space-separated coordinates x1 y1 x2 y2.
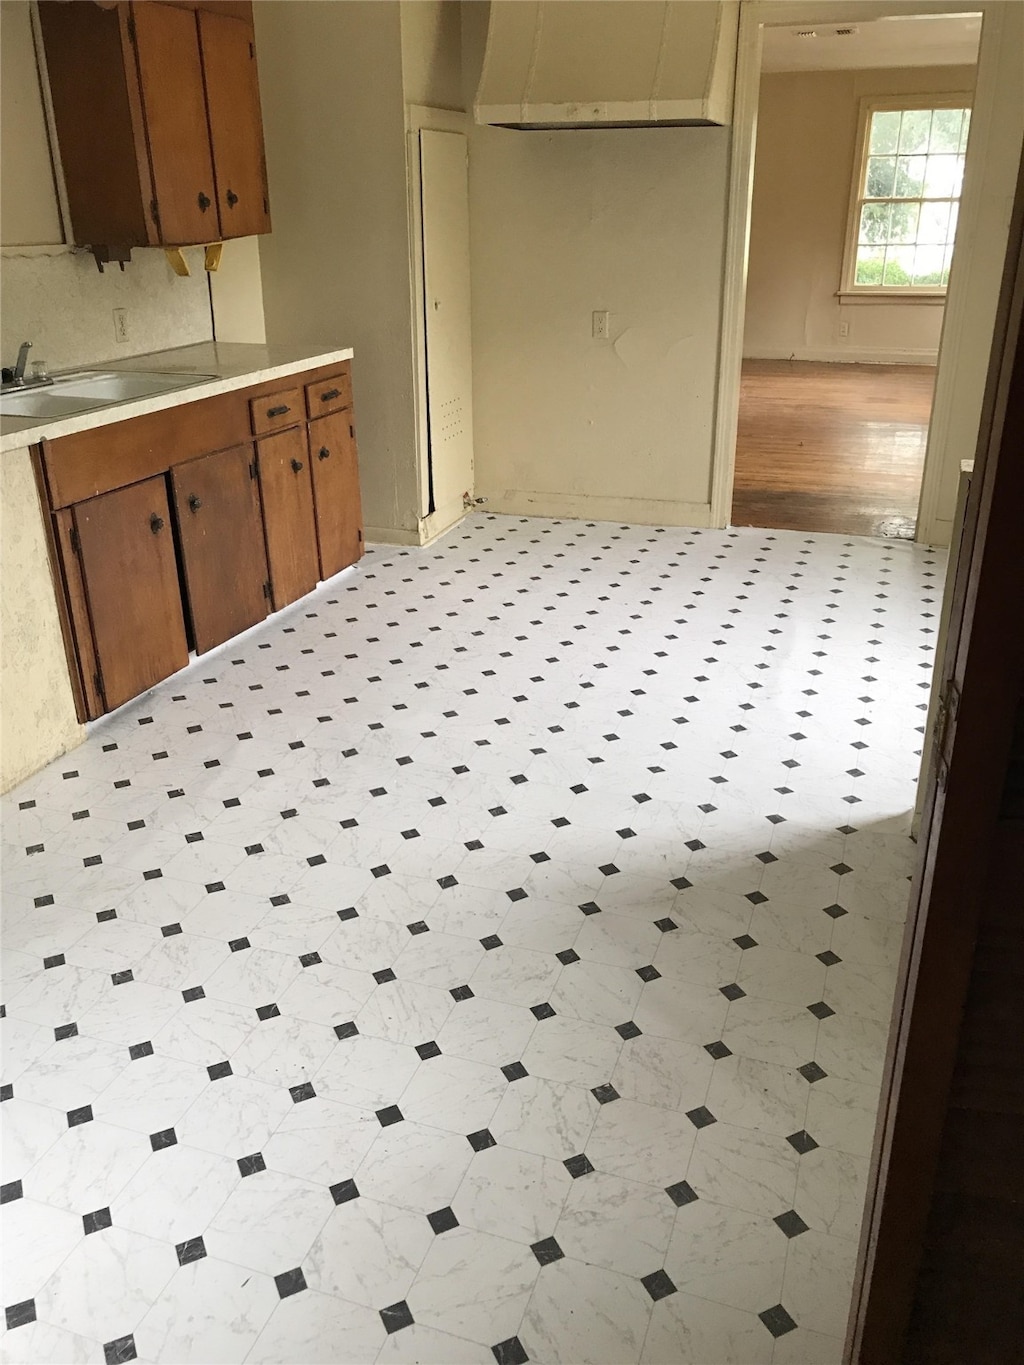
131 0 221 246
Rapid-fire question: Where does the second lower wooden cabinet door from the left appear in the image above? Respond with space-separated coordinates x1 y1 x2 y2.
171 445 269 654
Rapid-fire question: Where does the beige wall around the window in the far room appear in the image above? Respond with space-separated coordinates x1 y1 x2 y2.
744 67 975 363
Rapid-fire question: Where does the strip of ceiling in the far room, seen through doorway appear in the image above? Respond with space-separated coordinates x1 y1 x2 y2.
762 14 982 71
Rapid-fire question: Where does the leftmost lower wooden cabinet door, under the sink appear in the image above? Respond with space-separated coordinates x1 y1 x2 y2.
72 475 188 711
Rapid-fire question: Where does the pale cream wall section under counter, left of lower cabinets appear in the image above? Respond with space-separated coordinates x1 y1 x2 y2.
0 450 85 792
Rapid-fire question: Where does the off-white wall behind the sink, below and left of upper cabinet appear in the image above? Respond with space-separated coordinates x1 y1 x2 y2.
0 0 212 369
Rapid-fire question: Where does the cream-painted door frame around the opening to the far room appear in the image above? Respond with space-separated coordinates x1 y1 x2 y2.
711 0 1002 543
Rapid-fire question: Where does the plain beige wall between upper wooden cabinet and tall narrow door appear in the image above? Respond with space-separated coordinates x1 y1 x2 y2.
255 0 418 536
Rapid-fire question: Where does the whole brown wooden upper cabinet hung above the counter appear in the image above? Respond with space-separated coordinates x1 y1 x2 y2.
40 0 270 261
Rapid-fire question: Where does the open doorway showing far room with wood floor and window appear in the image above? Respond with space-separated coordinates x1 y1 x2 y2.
732 14 980 539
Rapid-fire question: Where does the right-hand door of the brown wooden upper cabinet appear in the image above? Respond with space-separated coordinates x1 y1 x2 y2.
198 10 270 238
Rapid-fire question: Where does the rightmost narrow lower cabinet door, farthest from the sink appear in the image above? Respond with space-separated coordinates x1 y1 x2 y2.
310 408 363 579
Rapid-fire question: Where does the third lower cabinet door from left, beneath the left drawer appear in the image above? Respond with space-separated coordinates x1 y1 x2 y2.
257 426 319 612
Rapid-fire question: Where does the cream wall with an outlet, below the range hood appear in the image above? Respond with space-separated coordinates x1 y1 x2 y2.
463 5 729 526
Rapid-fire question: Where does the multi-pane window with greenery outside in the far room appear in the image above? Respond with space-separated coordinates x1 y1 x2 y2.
842 94 971 296
